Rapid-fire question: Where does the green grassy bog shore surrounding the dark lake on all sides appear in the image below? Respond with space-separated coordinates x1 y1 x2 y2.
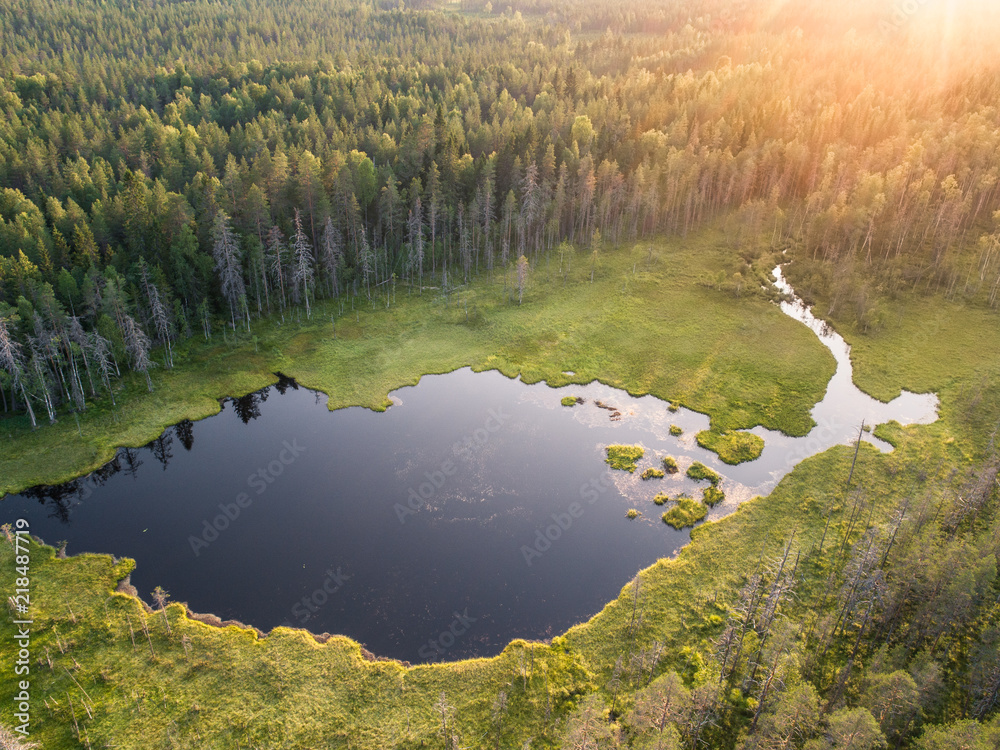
0 236 1000 749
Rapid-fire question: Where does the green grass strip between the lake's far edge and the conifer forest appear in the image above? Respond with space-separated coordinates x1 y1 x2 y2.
0 230 834 493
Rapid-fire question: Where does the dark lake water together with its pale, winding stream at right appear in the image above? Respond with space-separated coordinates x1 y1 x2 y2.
0 278 937 662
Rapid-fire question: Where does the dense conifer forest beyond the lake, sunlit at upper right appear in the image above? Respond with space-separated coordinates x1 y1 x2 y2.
0 0 1000 423
